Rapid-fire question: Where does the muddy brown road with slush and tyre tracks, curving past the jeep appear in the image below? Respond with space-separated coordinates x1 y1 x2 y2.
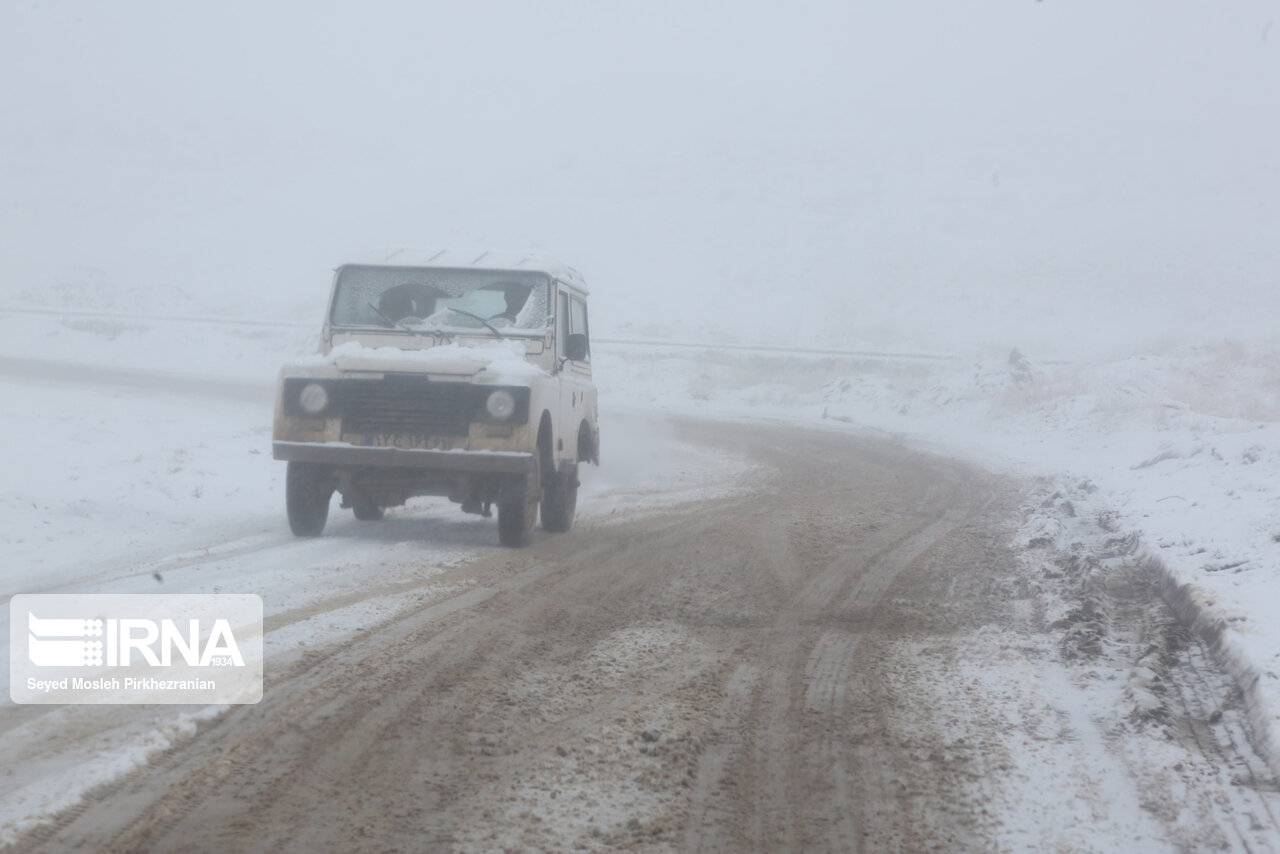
4 423 1280 851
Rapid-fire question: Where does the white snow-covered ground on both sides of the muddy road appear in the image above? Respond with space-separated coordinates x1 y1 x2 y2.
0 299 1280 841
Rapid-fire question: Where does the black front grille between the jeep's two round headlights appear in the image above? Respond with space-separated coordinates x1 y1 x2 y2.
342 375 471 435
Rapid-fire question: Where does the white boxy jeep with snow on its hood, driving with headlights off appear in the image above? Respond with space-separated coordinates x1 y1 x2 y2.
273 252 600 545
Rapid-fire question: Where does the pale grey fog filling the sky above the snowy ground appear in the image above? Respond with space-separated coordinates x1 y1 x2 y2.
0 0 1280 357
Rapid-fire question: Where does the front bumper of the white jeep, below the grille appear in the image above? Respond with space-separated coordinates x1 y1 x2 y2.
271 440 538 475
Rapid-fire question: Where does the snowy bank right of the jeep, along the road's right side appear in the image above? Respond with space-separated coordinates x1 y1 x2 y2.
598 341 1280 767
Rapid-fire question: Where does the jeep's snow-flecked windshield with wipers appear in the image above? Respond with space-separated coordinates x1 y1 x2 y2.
330 266 550 334
